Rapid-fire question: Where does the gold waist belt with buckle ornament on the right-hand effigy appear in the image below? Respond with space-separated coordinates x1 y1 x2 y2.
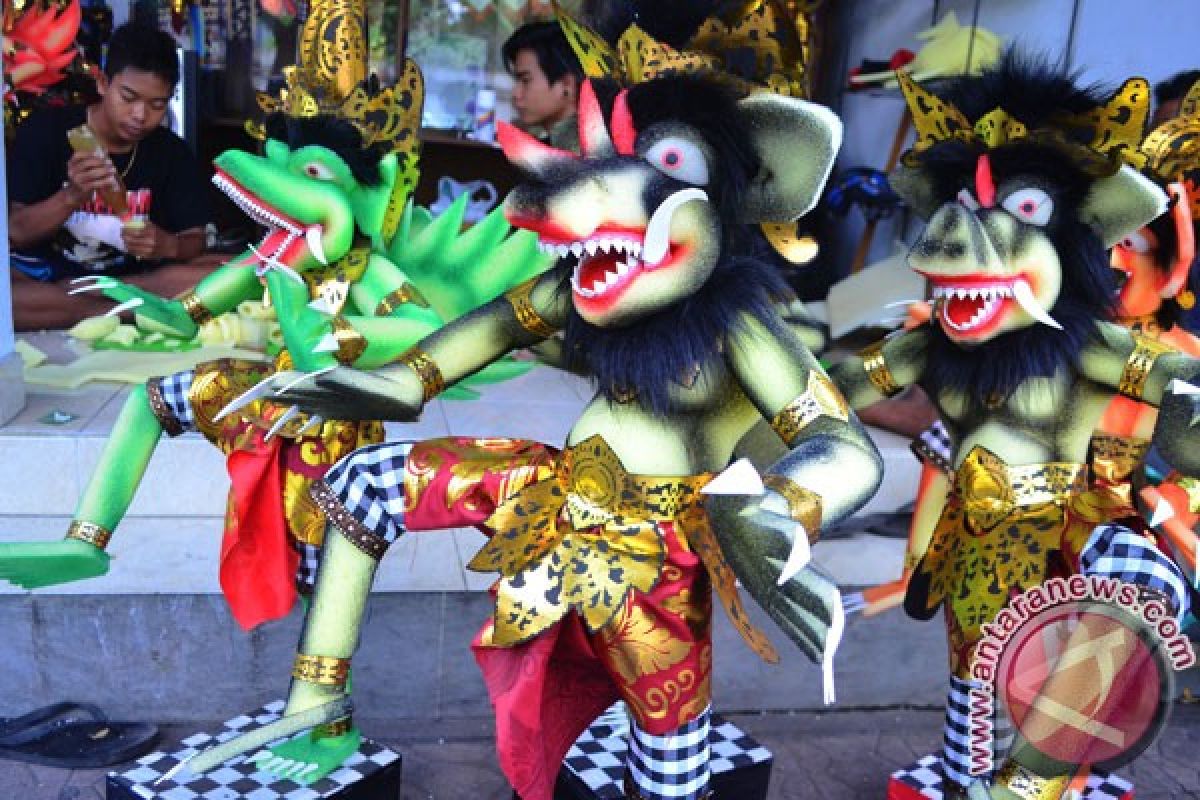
952 446 1087 531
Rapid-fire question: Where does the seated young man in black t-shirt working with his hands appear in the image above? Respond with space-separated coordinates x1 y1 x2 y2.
8 24 211 331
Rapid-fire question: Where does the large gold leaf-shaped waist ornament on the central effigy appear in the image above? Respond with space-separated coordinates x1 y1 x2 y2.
469 435 712 645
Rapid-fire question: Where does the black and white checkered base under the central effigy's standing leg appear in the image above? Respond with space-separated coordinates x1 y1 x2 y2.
554 703 774 800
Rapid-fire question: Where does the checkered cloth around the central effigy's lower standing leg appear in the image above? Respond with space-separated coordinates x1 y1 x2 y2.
628 709 710 800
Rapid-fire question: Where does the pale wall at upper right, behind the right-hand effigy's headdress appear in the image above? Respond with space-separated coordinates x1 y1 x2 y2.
826 0 1200 284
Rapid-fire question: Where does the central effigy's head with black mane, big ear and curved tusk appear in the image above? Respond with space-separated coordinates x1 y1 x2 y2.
500 74 840 408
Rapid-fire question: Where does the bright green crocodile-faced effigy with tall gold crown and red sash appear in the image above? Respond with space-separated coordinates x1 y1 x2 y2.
0 2 550 628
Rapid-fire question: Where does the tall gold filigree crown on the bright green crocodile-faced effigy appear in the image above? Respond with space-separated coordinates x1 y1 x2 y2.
247 0 425 156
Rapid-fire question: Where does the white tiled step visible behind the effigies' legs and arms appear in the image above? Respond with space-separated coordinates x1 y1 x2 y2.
0 335 917 594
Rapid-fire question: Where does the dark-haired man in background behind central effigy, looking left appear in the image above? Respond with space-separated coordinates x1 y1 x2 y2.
502 22 583 152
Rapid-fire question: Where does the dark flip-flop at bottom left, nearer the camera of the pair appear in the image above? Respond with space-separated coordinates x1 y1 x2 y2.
0 706 158 769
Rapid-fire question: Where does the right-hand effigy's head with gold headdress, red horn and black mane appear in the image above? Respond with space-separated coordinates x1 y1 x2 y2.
890 53 1165 395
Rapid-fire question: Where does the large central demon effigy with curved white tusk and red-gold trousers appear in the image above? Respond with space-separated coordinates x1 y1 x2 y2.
177 18 881 800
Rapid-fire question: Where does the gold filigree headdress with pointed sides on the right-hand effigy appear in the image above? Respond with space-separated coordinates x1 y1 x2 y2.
896 72 1150 173
